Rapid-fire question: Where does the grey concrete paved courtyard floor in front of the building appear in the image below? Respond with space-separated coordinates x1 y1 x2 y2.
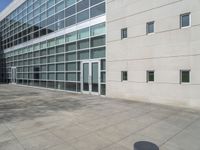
0 85 200 150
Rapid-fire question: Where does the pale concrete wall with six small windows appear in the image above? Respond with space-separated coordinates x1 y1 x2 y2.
106 0 200 108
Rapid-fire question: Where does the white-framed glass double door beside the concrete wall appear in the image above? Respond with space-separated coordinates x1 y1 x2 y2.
81 61 100 95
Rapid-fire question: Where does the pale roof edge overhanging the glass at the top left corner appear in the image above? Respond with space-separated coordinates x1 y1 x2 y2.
0 0 26 21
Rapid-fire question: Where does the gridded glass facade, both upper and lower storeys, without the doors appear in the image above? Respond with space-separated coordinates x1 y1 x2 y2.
0 0 106 95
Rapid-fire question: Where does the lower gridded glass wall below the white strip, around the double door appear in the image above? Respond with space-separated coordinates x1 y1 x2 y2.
6 23 106 95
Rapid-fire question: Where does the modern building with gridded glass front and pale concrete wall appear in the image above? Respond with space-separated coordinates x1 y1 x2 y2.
0 0 200 108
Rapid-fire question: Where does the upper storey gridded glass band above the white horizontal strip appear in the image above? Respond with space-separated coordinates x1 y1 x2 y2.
0 0 105 49
